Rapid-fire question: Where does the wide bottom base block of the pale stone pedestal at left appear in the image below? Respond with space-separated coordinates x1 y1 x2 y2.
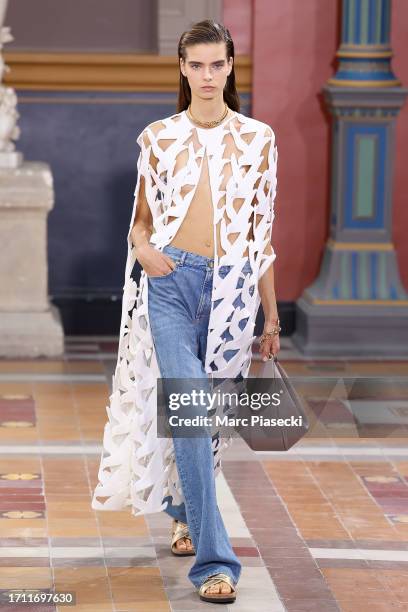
0 305 64 358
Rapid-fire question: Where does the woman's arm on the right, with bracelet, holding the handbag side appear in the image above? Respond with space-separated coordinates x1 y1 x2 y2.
258 127 280 361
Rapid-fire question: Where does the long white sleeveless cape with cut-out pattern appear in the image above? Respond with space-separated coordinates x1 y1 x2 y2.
92 111 278 516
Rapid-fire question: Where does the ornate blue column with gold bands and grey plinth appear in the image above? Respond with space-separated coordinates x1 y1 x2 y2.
292 0 408 356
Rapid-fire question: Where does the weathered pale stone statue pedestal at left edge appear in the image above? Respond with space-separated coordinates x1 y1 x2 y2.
0 162 64 357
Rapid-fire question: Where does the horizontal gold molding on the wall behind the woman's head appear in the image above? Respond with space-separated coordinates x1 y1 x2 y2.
3 52 252 92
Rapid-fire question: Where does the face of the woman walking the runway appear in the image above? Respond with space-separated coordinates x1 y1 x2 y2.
180 42 233 99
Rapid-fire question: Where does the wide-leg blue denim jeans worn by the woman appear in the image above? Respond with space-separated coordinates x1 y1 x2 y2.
147 245 251 587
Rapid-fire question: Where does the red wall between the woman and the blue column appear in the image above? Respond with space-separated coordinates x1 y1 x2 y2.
252 0 340 301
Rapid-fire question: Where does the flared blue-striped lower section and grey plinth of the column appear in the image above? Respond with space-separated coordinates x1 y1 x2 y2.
292 237 408 357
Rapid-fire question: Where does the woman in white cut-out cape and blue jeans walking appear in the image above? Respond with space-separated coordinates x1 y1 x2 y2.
92 20 280 602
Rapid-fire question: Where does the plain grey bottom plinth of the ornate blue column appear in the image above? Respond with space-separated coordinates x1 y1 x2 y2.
291 297 408 357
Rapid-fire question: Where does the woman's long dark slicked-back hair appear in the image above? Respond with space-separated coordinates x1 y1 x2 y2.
177 19 240 113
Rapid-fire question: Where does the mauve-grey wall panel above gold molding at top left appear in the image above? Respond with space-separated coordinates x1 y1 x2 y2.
5 0 157 53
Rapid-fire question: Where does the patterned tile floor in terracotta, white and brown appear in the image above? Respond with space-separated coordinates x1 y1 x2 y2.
0 337 408 612
